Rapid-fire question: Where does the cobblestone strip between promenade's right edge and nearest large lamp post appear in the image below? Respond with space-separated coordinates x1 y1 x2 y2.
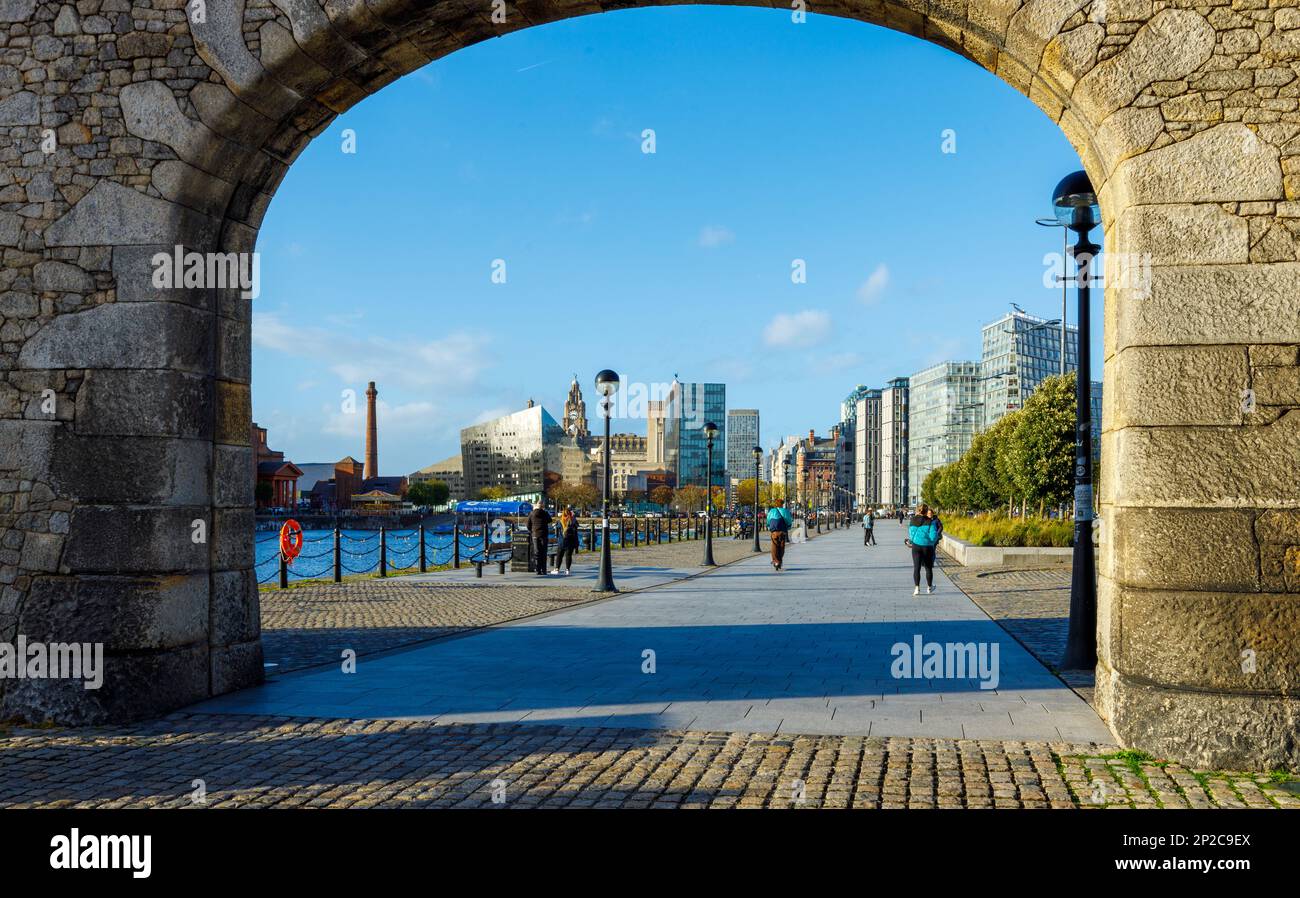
941 555 1096 704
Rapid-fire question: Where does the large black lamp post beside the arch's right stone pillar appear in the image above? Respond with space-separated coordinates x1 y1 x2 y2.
1052 172 1101 671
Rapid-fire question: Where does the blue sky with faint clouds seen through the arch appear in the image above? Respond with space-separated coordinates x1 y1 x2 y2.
254 6 1101 474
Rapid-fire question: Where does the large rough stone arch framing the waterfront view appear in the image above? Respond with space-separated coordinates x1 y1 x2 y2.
0 0 1300 765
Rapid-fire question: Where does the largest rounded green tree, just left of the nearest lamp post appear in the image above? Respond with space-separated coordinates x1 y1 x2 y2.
1009 373 1075 507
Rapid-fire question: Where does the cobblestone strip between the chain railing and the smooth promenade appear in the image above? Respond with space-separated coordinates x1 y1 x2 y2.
260 538 774 673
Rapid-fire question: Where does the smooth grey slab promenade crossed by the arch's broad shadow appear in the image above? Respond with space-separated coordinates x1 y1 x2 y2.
195 521 1110 745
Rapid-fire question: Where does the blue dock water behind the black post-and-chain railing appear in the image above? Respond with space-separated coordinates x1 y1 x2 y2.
254 528 702 584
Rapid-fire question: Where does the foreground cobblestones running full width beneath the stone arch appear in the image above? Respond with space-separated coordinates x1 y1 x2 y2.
0 713 1300 808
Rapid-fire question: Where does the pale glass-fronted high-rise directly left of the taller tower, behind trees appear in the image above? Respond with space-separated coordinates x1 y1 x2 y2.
907 361 983 506
